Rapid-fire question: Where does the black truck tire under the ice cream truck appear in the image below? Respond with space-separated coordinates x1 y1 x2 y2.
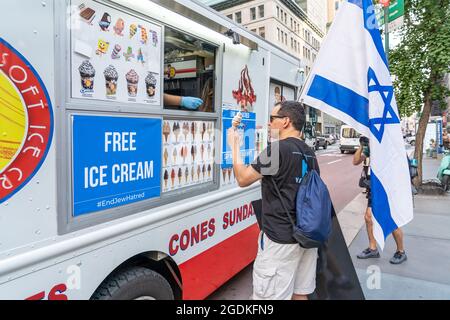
91 267 174 300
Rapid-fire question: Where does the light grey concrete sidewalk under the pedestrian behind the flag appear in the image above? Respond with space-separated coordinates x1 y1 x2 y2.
338 154 450 300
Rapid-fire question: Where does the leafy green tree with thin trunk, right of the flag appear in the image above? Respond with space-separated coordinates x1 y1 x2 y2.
390 0 450 186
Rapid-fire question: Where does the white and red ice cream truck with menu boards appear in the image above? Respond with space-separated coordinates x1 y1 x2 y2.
0 0 302 300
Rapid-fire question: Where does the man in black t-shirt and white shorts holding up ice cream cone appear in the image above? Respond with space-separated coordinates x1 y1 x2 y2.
228 101 319 300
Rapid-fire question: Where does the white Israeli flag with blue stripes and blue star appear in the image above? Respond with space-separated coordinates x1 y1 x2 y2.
300 0 413 249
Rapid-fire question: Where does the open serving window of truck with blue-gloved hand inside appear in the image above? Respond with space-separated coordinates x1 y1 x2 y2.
164 27 216 112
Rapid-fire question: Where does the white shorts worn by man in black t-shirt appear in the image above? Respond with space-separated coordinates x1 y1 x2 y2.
253 232 317 300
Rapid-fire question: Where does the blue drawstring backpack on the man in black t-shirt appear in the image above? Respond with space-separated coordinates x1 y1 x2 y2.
272 154 334 249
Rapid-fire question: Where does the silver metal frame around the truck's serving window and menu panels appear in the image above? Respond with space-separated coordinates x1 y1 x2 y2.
55 0 223 235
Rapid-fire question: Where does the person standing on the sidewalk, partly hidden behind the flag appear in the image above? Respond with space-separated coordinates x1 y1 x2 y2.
353 136 407 264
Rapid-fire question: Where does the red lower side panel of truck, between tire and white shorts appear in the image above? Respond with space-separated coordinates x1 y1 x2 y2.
180 223 259 300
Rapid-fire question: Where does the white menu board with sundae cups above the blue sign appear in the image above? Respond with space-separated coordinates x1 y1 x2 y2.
70 0 162 105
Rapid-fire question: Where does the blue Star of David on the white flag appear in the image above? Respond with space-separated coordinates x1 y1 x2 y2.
367 68 400 143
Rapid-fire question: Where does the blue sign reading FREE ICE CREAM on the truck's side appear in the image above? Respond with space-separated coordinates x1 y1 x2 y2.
72 116 162 216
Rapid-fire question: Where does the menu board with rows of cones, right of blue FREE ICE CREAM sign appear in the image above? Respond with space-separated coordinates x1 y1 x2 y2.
162 120 215 192
